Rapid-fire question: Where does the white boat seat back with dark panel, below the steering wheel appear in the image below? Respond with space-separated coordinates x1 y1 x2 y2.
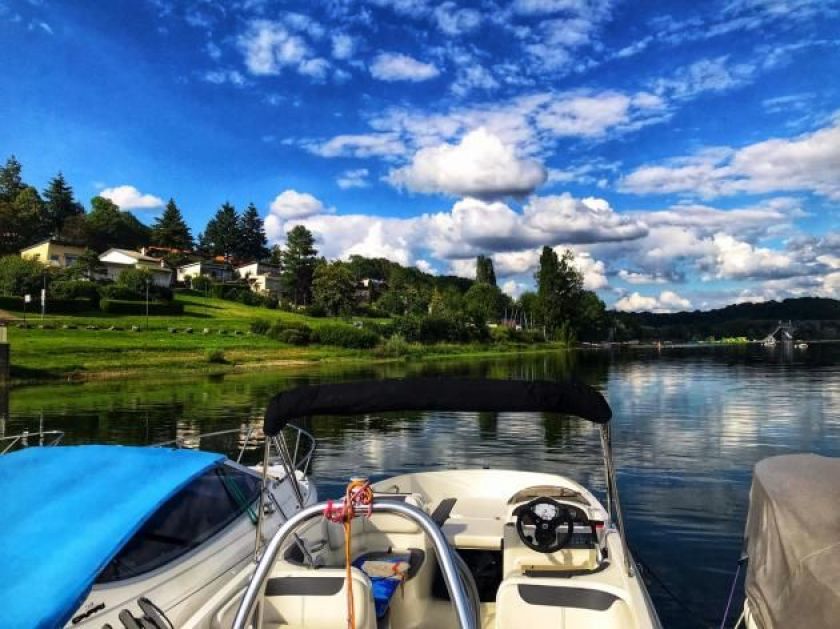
496 577 636 629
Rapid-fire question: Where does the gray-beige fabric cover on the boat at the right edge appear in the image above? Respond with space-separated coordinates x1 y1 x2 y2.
745 454 840 629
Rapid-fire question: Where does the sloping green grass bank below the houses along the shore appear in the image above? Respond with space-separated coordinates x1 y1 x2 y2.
3 295 560 382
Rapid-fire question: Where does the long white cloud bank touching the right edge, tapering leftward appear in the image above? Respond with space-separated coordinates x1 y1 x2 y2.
620 120 840 200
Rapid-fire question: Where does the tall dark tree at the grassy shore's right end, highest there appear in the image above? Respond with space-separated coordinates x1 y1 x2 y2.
536 247 583 336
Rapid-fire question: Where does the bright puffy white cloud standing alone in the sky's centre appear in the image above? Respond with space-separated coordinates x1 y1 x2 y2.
388 128 546 198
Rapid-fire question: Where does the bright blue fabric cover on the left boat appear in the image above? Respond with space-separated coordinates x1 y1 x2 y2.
0 446 224 629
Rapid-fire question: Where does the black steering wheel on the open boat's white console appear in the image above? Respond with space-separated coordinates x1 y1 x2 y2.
516 498 589 554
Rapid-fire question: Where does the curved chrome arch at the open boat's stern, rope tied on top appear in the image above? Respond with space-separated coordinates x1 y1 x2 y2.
233 500 478 629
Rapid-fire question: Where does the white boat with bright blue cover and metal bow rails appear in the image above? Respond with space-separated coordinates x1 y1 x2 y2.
0 427 317 629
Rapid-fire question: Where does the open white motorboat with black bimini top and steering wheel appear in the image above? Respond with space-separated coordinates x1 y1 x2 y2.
215 378 661 629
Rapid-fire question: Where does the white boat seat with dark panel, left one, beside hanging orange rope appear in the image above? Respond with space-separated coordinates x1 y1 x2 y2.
262 568 376 629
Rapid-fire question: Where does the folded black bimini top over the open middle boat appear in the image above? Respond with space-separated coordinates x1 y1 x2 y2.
264 378 612 435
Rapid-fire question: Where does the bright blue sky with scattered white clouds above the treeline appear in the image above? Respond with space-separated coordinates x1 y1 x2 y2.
0 0 840 311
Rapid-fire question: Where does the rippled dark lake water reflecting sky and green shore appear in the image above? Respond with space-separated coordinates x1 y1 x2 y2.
0 344 840 627
